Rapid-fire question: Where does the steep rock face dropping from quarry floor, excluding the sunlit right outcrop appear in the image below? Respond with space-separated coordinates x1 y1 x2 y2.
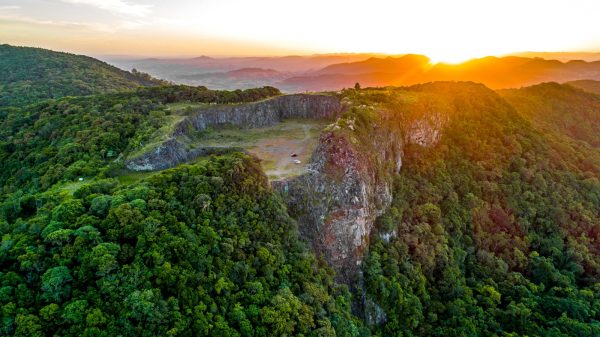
274 114 403 284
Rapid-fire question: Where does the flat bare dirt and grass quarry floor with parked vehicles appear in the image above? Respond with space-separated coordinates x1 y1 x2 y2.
198 119 328 180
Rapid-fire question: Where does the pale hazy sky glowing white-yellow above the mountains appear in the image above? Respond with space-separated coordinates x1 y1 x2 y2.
0 0 600 61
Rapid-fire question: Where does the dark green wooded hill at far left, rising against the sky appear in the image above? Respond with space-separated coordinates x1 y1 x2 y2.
0 44 165 107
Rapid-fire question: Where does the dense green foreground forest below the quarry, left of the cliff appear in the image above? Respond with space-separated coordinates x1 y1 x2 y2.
0 155 360 336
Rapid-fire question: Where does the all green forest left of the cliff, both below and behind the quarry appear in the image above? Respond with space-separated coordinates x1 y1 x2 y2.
0 86 367 336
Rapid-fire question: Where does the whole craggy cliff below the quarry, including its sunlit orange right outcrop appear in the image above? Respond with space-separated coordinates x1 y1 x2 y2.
273 93 447 286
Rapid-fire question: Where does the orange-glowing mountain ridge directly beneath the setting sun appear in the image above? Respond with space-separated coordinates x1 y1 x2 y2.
278 55 600 91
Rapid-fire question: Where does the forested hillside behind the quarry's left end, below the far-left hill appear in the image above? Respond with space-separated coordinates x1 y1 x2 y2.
0 86 280 197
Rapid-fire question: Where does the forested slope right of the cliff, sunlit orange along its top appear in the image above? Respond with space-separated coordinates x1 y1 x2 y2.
340 83 600 337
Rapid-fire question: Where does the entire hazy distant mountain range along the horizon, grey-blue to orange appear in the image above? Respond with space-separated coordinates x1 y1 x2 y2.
108 53 600 92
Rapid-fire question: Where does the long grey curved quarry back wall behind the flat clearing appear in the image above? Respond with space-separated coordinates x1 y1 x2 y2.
125 94 342 171
